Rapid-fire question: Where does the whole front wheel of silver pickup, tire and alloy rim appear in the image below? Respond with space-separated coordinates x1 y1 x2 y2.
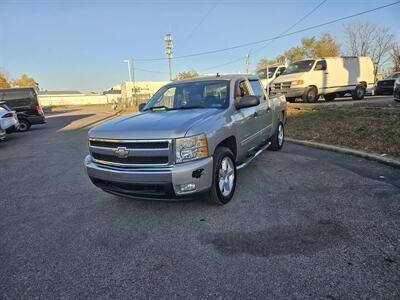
209 147 236 205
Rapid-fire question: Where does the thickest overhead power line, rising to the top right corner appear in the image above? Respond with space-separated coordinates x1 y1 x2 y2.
136 1 400 61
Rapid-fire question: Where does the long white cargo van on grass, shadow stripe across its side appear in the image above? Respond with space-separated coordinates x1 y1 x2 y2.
271 56 374 102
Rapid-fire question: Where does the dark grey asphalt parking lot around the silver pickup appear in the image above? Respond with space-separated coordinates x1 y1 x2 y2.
0 103 400 299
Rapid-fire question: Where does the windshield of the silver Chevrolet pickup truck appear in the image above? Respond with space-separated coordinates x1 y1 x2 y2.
143 80 229 110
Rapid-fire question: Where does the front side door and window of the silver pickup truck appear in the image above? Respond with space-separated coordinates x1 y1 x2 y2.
234 80 260 153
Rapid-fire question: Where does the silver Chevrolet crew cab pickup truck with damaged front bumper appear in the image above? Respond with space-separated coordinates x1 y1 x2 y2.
84 75 287 204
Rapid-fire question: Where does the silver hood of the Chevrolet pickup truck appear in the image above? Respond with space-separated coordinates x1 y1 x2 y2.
89 108 223 140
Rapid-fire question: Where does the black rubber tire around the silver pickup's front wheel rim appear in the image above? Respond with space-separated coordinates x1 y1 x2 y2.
208 147 237 205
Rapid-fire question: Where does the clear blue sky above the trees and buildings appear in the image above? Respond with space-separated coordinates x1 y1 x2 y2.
0 0 400 91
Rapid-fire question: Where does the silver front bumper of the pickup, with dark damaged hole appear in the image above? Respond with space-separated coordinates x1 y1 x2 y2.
85 155 213 200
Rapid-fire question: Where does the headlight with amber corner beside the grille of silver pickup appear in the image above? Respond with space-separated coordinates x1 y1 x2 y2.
175 134 208 163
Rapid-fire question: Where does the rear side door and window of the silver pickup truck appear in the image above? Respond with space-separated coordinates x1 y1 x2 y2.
249 79 272 138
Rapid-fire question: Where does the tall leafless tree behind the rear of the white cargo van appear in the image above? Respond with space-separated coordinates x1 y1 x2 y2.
345 22 394 77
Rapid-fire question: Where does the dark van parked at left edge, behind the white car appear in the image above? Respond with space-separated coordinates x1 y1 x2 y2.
0 88 46 131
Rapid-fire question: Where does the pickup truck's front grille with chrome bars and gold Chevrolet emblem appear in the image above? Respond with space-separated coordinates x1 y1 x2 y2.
89 138 173 167
